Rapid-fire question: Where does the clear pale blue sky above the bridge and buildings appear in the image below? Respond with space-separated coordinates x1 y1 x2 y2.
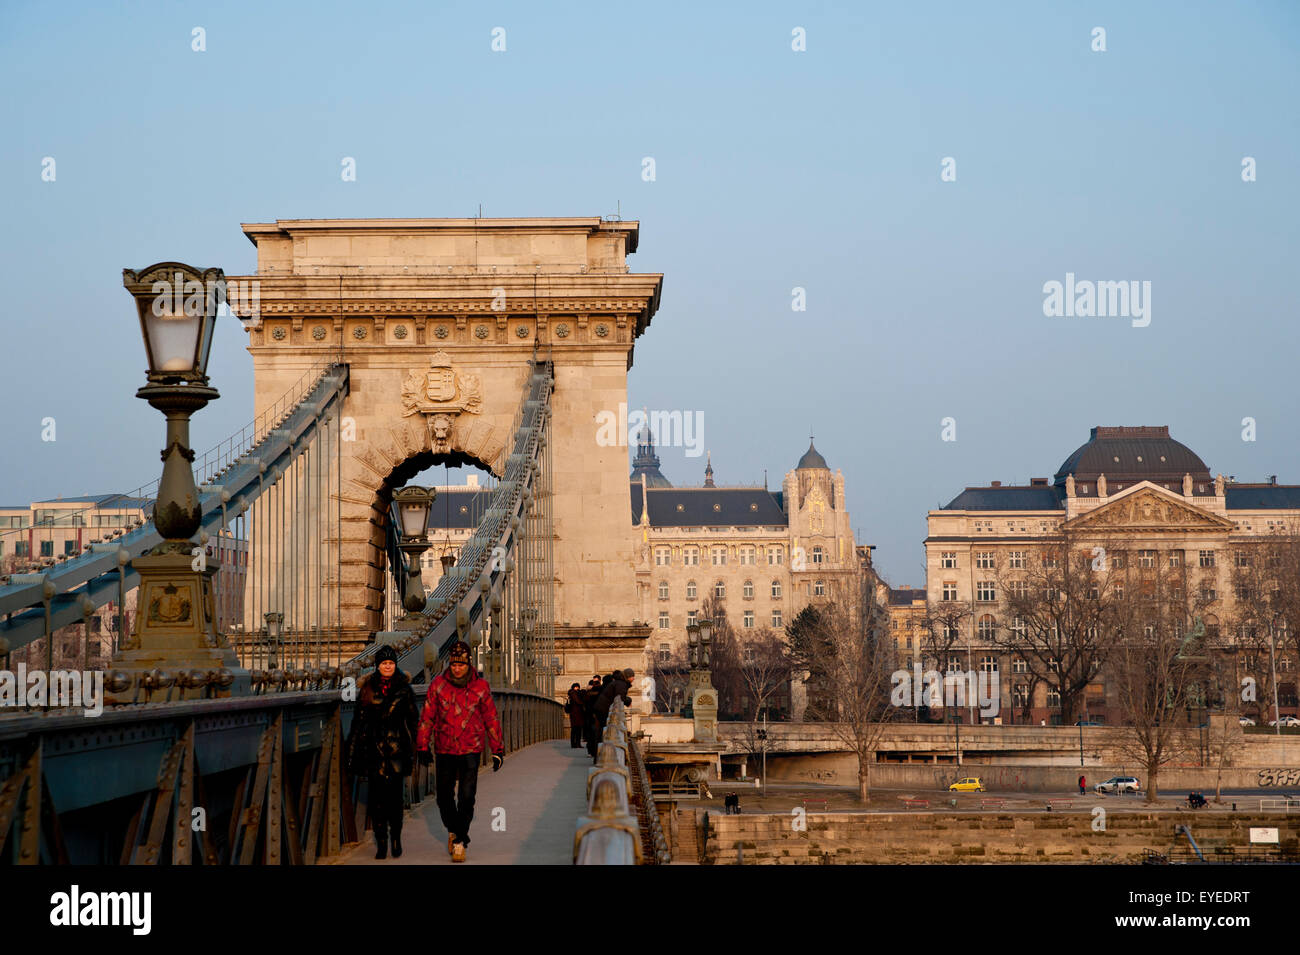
0 1 1300 586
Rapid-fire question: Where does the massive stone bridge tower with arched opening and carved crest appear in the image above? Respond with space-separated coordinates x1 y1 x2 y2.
230 218 663 691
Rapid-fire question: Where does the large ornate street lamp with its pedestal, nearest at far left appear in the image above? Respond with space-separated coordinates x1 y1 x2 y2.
111 262 247 702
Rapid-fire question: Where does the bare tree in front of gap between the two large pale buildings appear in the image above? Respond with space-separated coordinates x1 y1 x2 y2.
790 573 898 802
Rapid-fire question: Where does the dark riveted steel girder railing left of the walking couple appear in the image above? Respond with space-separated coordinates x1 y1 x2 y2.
0 689 563 865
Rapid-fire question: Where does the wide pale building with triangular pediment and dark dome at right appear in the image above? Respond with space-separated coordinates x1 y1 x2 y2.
926 426 1300 724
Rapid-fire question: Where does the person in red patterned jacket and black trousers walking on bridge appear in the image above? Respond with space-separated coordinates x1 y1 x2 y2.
416 641 506 863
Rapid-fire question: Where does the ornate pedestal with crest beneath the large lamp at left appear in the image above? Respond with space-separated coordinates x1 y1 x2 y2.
108 548 248 703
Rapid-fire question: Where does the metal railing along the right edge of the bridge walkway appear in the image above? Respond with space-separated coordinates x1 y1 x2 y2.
573 699 670 865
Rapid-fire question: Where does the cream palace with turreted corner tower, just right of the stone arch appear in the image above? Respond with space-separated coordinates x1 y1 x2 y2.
631 434 870 715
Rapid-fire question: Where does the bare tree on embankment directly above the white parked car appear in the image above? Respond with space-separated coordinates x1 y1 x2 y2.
1108 551 1214 803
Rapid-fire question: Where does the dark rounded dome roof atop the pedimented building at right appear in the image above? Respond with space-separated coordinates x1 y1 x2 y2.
1054 425 1210 486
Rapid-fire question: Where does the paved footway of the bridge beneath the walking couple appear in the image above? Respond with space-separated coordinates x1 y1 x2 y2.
337 739 592 865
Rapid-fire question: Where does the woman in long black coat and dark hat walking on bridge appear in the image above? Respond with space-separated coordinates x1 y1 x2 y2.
347 647 420 859
